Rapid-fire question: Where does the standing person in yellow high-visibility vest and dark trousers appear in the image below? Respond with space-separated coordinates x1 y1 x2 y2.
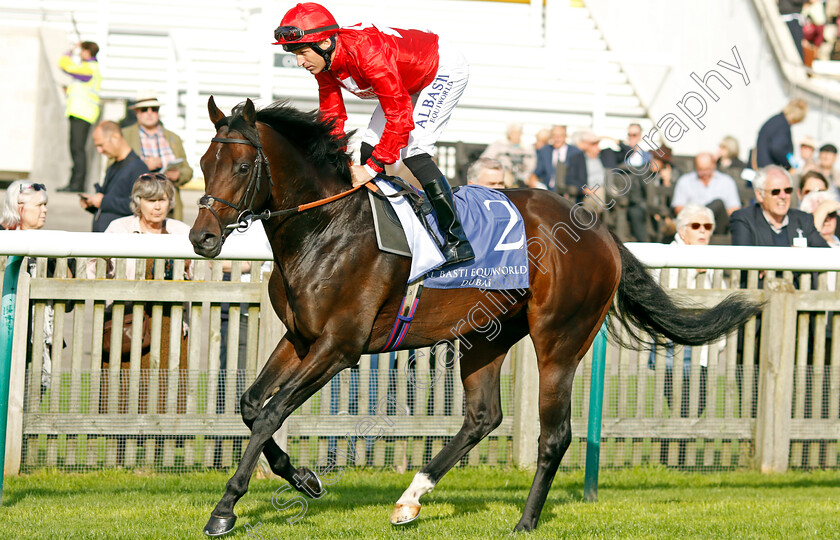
58 41 102 192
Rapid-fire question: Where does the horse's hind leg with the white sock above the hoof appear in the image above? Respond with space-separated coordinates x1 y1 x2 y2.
391 340 507 525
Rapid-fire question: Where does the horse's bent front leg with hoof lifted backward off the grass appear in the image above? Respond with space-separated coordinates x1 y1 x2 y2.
240 337 322 497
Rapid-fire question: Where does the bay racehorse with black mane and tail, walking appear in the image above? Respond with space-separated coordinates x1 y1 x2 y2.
190 97 761 535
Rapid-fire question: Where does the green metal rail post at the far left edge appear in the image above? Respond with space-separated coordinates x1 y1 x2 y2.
0 256 23 504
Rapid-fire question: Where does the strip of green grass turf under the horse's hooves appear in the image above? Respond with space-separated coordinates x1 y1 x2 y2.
0 467 840 540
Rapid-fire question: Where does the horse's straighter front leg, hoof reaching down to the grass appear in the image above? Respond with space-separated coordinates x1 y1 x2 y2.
204 337 361 536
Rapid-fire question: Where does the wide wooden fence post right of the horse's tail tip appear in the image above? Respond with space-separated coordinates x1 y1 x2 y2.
756 279 796 473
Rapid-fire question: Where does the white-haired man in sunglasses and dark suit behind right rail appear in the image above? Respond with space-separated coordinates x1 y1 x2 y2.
730 165 828 247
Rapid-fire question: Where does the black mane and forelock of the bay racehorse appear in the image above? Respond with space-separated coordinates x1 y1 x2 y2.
228 101 352 183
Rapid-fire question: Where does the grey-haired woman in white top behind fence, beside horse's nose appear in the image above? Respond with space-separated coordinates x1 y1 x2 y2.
87 173 192 414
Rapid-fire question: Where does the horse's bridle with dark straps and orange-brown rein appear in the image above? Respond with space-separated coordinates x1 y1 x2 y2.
198 118 378 240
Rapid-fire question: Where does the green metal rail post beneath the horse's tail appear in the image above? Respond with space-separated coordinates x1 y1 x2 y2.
583 320 607 502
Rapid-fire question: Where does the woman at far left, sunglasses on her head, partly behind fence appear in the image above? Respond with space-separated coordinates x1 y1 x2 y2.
0 184 56 391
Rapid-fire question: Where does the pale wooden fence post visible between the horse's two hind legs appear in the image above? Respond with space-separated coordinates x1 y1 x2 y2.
513 336 540 468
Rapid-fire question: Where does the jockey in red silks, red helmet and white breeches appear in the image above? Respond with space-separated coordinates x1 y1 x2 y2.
274 2 475 264
